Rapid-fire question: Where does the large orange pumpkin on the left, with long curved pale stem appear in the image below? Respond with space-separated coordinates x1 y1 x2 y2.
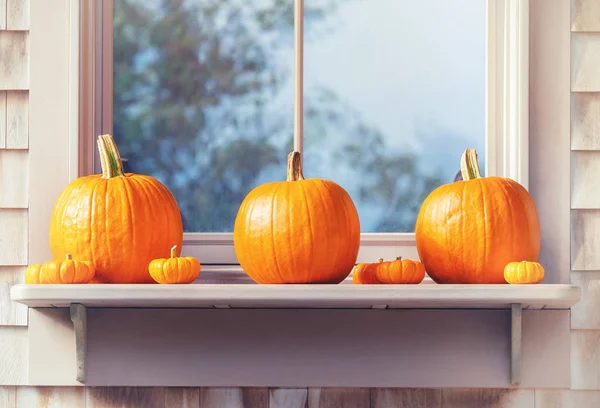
50 135 183 283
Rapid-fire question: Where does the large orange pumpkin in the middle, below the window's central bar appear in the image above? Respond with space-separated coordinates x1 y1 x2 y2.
233 152 360 283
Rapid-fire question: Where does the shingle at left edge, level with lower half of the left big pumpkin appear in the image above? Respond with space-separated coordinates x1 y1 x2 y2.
0 209 28 266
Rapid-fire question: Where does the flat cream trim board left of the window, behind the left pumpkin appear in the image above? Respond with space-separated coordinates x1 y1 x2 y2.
27 0 79 263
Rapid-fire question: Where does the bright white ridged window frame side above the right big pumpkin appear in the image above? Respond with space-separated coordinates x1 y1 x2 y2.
486 0 529 189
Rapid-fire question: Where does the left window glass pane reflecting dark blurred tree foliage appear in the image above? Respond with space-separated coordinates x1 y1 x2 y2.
113 0 296 232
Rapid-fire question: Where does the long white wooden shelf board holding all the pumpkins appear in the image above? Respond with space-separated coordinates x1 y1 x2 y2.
10 284 581 309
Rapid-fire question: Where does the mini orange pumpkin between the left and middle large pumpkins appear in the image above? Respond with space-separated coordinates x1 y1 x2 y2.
148 245 200 284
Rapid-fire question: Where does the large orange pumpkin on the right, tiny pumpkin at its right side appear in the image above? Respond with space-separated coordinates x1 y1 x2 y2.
415 149 540 283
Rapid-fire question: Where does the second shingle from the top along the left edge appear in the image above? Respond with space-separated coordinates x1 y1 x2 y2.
0 31 29 90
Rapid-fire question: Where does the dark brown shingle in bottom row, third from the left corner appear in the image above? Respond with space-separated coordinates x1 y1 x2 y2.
85 387 165 408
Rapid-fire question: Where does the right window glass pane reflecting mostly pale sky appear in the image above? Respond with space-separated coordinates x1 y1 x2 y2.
304 0 486 232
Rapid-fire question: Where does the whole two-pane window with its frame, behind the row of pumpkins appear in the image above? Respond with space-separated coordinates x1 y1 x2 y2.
82 0 528 264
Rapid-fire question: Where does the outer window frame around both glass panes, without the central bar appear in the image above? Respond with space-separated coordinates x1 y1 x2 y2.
78 0 529 272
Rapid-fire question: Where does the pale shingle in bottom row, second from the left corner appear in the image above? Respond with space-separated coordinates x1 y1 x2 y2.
16 387 85 408
